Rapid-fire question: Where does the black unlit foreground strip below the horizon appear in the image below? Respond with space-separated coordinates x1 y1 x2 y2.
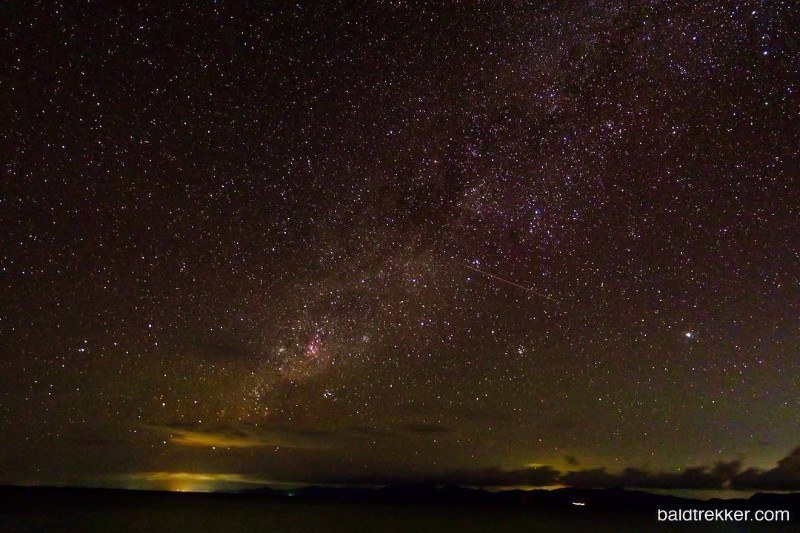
0 486 800 533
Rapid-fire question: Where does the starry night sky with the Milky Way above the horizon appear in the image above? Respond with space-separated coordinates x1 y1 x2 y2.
0 0 800 489
